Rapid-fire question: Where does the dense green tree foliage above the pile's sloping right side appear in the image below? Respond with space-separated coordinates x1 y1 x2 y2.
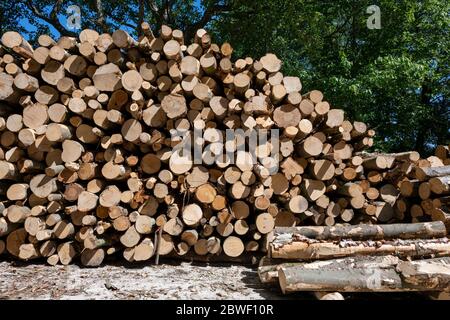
214 0 450 153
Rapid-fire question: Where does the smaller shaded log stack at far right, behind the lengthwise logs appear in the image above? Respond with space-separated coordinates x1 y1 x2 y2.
354 146 450 225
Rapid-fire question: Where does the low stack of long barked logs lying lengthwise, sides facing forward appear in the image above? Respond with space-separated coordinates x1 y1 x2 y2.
258 221 450 293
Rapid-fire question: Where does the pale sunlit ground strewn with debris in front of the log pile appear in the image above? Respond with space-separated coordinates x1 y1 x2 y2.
0 261 426 300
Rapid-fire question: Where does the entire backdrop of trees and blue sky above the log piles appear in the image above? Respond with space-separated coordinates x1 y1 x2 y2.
0 0 450 155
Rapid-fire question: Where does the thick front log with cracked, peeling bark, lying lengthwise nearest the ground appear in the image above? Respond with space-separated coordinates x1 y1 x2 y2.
278 256 450 293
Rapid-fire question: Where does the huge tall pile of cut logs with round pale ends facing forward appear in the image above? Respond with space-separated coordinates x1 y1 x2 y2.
0 22 448 266
